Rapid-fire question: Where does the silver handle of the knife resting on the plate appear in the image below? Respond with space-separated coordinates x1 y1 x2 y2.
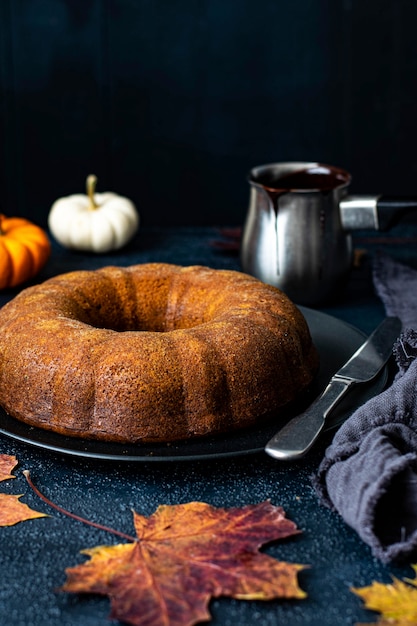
265 376 352 461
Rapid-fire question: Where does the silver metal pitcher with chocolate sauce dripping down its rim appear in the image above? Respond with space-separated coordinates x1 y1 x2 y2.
241 162 417 306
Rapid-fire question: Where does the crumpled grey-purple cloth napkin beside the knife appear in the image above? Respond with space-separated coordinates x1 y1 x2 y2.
313 256 417 562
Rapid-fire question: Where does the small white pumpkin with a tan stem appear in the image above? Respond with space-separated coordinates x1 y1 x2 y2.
48 175 139 252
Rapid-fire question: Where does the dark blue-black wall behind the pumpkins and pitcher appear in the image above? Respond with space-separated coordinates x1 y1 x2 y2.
0 0 417 225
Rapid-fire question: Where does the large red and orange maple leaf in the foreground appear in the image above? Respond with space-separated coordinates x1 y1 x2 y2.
63 502 306 626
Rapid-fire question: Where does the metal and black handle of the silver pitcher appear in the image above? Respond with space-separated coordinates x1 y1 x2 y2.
339 195 417 231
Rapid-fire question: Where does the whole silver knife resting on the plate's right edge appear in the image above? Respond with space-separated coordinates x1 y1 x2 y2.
265 317 401 461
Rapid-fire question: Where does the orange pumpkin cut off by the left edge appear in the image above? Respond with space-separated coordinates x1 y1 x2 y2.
0 214 51 289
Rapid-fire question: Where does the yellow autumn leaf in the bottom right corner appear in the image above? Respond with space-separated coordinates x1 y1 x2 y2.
352 565 417 626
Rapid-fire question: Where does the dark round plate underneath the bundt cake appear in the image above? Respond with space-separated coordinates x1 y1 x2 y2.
0 307 387 462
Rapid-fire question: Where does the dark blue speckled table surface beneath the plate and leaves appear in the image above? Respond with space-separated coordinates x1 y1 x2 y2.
0 223 417 626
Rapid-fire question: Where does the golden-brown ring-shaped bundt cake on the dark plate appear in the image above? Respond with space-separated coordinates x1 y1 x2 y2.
0 263 318 442
